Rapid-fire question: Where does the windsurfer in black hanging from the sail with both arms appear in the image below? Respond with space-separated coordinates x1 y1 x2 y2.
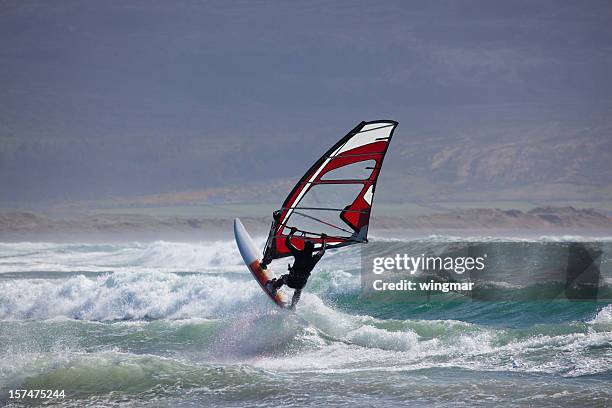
266 227 327 309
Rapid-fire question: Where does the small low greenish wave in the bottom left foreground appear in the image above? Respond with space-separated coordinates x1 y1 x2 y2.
0 351 273 400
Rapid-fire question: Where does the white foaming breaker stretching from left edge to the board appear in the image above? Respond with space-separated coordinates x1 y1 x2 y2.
0 271 260 321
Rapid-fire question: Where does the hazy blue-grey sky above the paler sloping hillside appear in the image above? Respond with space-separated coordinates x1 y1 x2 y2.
0 0 612 202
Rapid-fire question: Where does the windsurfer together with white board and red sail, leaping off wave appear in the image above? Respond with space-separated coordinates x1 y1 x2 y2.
234 120 397 308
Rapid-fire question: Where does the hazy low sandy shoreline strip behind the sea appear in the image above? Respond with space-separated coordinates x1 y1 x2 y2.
0 207 612 242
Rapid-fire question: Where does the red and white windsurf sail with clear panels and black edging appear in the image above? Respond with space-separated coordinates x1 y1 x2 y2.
263 120 398 265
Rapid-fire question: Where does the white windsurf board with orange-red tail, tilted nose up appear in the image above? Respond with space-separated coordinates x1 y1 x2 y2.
234 218 287 308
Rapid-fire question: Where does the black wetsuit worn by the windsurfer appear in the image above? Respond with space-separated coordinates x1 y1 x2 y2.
273 233 325 308
